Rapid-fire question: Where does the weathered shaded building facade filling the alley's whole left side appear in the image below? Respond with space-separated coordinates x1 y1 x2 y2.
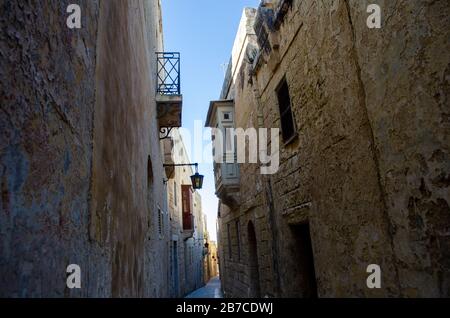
0 0 186 297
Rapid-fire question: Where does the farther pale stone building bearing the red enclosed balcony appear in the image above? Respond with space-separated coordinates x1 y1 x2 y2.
166 129 205 297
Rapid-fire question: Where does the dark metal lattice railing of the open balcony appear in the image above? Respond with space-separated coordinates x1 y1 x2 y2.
156 52 181 95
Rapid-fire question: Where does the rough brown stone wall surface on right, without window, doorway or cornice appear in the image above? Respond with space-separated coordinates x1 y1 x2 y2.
258 1 449 297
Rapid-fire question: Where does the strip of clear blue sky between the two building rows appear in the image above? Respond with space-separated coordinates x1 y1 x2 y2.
162 0 259 240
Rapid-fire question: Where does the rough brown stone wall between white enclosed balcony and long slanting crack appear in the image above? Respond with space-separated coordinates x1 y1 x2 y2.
253 1 396 296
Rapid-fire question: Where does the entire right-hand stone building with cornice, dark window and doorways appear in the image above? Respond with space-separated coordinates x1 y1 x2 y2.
207 0 450 297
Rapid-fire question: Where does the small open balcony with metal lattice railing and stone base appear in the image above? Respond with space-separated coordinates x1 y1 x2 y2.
156 52 183 132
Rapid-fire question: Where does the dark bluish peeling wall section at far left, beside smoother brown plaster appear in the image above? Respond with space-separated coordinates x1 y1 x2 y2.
0 1 101 297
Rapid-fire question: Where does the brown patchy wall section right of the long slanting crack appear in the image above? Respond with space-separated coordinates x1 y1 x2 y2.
348 0 450 297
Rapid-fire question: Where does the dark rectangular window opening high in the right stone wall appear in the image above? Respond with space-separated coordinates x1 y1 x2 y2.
277 79 296 144
